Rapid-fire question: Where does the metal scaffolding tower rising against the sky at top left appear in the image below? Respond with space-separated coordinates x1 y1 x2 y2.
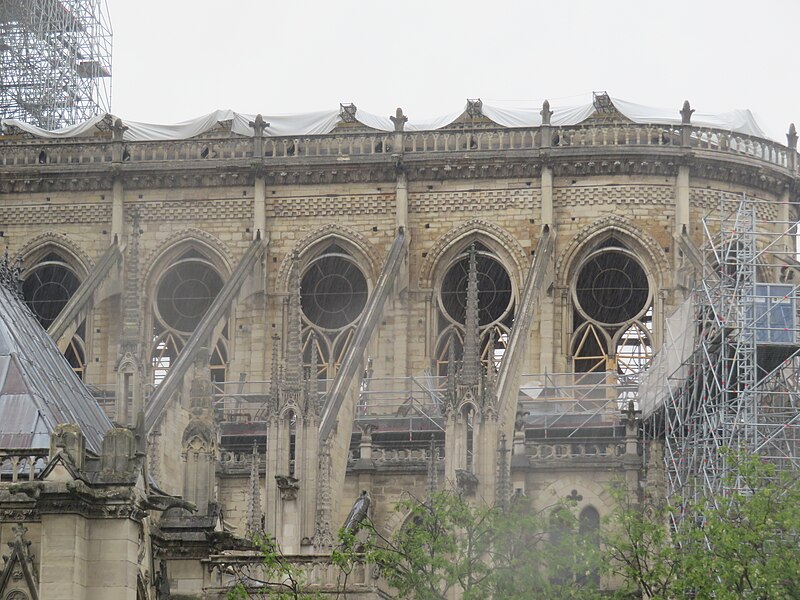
0 0 112 129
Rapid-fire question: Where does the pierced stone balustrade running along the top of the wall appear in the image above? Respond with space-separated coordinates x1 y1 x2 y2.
0 123 797 169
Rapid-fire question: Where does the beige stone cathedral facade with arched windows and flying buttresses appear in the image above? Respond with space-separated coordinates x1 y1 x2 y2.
0 101 800 600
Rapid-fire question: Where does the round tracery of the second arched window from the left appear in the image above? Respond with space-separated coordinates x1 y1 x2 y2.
155 258 222 333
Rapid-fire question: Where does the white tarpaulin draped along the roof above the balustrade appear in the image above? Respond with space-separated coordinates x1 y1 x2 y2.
0 98 766 142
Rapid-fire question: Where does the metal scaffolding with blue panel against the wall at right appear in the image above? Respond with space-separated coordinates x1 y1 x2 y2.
640 198 800 502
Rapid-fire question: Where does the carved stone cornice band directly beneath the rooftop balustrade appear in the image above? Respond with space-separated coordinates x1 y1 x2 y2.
0 146 800 196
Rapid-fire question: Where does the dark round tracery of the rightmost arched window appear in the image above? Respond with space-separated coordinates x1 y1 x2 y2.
575 249 650 325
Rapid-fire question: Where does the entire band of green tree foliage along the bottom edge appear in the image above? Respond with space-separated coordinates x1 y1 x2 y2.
229 453 800 600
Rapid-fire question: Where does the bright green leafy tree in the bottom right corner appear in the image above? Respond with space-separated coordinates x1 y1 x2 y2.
604 452 800 600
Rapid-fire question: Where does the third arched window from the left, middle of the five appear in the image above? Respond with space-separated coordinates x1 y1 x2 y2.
300 243 369 379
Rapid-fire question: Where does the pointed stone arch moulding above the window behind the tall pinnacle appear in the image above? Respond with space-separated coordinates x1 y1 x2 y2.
419 219 530 289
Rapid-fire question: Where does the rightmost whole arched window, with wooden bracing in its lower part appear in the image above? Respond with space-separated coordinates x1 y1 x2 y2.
570 237 653 383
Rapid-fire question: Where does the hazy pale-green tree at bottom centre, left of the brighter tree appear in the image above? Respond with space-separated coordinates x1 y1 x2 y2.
340 492 601 600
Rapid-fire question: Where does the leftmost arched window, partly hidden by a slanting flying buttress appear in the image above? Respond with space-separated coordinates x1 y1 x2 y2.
22 252 86 379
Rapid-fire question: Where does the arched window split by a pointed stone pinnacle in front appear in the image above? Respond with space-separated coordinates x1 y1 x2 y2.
435 242 515 375
